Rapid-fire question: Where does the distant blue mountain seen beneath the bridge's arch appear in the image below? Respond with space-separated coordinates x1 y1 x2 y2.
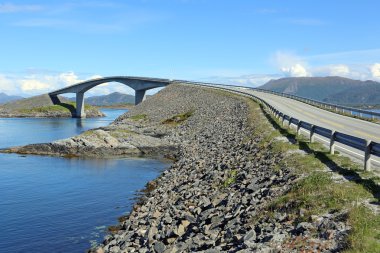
69 92 135 106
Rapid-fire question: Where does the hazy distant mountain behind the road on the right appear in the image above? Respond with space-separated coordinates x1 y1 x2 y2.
259 76 380 105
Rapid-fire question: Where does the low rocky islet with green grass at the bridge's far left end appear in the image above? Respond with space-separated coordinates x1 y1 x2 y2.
0 94 105 118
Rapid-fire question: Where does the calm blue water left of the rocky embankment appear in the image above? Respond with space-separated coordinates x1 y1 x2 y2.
0 110 168 253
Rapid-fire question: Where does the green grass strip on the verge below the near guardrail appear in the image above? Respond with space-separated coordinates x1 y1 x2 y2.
243 96 380 253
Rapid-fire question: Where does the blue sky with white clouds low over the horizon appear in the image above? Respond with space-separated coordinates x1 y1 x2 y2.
0 0 380 96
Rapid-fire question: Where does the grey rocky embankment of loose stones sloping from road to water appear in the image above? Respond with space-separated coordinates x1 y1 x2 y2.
3 85 349 253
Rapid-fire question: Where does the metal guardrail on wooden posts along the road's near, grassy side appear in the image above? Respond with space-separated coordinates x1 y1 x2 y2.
172 80 380 171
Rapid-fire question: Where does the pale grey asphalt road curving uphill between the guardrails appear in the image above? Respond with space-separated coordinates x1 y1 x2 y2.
228 87 380 171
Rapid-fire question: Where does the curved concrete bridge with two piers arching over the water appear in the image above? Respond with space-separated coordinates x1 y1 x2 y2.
49 76 171 118
